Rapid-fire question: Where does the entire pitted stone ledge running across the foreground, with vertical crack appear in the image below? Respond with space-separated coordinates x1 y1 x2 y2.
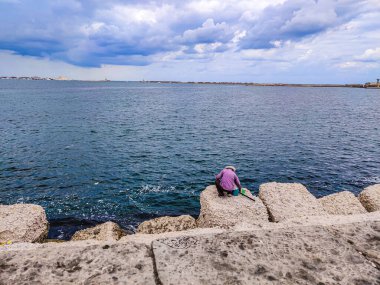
0 212 380 285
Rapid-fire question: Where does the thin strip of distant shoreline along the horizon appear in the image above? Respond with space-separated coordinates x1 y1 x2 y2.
0 76 380 89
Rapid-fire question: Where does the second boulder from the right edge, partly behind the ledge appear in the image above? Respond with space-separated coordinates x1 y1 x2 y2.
318 191 367 215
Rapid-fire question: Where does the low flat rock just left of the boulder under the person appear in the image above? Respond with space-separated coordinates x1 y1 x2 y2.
137 215 197 234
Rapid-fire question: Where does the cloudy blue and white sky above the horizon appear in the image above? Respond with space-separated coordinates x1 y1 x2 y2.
0 0 380 83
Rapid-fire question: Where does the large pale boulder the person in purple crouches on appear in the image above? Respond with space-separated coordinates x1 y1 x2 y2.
197 186 269 229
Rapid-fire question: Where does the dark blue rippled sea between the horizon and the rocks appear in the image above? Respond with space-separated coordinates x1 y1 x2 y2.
0 80 380 238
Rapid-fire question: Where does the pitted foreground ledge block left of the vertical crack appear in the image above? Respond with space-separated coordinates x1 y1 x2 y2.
0 242 156 285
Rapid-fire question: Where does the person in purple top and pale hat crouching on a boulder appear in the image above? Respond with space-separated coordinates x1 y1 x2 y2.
215 166 241 196
